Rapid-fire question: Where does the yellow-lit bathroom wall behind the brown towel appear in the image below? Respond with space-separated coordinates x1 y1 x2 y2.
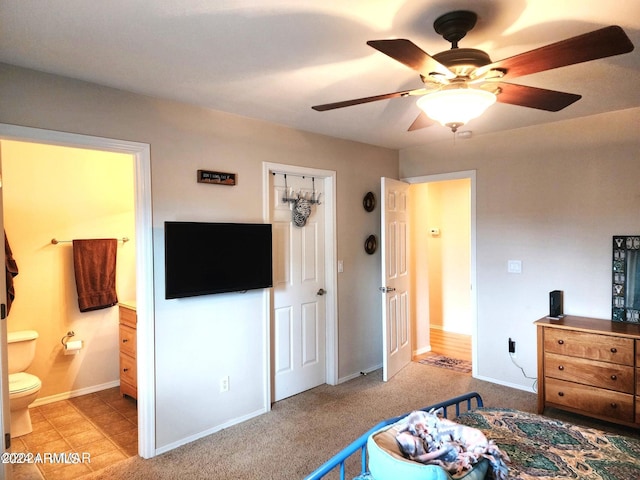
0 140 135 403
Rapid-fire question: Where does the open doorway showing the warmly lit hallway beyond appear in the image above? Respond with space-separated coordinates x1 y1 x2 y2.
409 172 477 376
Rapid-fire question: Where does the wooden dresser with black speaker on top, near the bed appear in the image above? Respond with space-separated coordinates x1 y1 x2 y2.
535 316 640 426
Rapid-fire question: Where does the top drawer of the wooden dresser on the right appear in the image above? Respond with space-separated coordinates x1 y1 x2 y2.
544 328 635 365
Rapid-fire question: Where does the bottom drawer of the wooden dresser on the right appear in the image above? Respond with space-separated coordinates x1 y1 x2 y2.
545 378 634 422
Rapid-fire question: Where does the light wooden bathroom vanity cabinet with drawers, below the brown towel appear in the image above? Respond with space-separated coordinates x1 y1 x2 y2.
119 302 138 398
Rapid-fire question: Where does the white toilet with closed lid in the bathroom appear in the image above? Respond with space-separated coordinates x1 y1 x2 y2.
7 330 42 438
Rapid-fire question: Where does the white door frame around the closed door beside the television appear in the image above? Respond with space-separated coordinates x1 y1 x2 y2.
262 162 338 406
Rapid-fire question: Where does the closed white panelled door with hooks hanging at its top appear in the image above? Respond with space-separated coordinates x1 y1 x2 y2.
271 174 326 401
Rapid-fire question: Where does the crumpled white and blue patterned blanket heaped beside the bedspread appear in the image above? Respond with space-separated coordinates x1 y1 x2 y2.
396 410 509 480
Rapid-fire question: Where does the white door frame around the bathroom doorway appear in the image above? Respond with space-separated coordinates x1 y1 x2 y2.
0 124 155 470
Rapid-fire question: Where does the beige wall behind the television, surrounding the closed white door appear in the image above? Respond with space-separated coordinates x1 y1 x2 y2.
0 65 398 450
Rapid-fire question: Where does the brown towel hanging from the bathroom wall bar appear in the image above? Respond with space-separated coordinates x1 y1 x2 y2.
73 238 118 312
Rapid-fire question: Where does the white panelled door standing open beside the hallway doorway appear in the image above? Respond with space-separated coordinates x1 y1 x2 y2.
380 177 411 382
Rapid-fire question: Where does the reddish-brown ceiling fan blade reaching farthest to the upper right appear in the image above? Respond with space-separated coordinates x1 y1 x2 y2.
475 25 633 78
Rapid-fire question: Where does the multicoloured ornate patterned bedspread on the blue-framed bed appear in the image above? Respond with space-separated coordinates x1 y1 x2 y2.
456 408 640 480
